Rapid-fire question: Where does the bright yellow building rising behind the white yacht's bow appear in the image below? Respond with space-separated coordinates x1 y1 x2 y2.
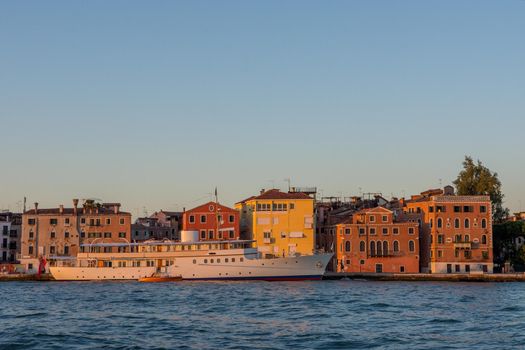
235 189 315 256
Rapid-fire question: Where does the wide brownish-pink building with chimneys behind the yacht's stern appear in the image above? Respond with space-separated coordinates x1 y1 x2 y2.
19 199 131 272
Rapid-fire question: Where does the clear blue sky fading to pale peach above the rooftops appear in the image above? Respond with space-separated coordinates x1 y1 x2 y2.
0 0 525 214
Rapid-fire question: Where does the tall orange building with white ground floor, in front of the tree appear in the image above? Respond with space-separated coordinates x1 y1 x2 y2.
405 186 493 273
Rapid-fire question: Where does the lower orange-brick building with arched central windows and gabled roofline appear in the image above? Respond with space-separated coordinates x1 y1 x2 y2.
334 207 420 273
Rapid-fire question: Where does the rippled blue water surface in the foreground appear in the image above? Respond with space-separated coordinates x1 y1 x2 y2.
0 281 525 350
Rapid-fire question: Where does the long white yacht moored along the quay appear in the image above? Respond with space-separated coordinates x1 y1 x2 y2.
49 234 332 281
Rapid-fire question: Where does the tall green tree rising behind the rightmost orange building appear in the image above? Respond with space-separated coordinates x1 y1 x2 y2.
454 156 509 223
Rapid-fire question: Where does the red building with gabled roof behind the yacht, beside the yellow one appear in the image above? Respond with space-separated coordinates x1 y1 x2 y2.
182 202 239 241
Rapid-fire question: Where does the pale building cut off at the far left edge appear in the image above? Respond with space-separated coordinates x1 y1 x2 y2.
0 212 22 264
